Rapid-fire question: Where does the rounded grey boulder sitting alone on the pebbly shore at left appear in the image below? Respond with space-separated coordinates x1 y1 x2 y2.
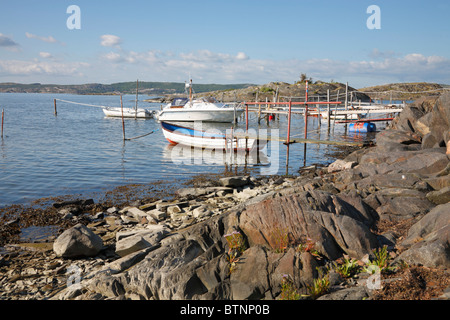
53 223 103 258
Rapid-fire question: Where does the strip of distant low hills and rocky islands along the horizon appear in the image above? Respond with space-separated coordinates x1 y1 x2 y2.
0 79 444 102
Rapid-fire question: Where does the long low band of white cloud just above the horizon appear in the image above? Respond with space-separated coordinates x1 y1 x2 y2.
0 46 450 88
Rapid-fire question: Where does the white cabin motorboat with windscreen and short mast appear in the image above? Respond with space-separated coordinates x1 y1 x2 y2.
156 80 244 122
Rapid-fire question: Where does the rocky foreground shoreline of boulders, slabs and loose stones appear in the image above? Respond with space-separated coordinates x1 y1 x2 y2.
0 94 450 300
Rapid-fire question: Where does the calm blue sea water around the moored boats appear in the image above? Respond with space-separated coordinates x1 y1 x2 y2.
0 93 378 207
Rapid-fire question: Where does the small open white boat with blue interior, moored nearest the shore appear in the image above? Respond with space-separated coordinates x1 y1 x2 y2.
161 121 267 151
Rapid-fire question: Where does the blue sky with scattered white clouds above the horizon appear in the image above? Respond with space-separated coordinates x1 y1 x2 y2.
0 0 450 88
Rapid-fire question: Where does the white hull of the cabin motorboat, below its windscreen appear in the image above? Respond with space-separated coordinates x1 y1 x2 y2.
157 108 244 122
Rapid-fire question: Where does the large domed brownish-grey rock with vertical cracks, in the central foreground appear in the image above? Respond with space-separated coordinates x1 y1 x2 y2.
239 191 378 259
